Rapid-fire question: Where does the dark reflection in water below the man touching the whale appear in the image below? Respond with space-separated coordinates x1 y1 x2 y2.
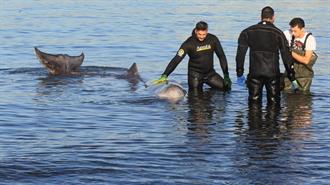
173 89 227 143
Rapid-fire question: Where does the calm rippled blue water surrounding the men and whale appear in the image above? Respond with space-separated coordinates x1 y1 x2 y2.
0 0 330 185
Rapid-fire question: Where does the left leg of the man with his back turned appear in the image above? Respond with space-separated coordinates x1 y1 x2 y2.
247 77 264 105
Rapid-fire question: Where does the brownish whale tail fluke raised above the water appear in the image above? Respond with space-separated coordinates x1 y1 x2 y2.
34 47 85 75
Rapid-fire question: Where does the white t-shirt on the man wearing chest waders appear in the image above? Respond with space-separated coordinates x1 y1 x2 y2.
283 30 316 51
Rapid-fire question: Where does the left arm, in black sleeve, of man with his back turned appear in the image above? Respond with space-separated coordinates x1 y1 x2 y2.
236 31 249 77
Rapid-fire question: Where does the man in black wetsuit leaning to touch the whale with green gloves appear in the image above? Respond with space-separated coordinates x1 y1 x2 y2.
154 21 231 91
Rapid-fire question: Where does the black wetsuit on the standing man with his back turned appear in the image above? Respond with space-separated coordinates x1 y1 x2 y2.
236 21 294 103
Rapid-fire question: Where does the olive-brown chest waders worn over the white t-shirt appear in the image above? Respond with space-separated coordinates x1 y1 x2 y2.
284 33 317 92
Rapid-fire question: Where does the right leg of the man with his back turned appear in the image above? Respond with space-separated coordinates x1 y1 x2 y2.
265 78 281 105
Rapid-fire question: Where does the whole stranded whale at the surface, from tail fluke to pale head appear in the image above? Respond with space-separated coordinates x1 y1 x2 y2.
34 47 187 102
